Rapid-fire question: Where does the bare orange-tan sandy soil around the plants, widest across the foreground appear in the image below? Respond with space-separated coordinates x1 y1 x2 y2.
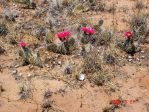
0 0 149 112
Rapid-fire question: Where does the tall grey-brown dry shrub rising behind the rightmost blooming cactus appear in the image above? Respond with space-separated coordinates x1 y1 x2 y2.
131 14 147 40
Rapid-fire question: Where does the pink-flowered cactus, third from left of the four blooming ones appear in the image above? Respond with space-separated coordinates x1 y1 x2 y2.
81 27 96 44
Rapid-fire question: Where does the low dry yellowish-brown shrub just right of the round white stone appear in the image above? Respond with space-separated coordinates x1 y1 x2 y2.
92 70 110 86
